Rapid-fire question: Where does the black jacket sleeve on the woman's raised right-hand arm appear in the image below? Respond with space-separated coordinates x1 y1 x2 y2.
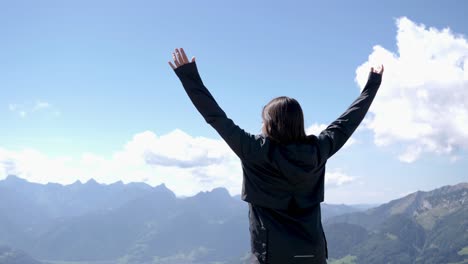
317 72 382 163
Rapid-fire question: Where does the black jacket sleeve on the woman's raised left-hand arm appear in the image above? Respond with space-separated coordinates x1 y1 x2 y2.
174 62 260 159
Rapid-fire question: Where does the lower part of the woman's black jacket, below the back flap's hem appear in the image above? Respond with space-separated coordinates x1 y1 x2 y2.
249 198 328 264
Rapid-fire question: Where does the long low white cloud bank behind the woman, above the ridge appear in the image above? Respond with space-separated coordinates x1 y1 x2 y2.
0 129 354 196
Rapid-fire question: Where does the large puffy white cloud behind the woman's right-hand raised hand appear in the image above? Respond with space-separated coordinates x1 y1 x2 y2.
356 17 468 163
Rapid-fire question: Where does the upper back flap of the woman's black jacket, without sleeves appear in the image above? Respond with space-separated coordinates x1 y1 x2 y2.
241 134 326 210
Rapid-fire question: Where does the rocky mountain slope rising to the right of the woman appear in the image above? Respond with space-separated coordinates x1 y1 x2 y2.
324 183 468 264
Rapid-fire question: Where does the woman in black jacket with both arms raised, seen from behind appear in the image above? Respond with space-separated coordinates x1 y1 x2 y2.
169 48 383 264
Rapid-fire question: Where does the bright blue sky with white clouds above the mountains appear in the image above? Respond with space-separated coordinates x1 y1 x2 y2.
0 0 468 203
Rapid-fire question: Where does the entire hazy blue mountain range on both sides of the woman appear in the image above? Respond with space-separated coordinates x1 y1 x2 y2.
0 175 468 264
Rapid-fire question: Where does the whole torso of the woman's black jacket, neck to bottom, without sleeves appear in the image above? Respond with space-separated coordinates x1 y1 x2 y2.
242 135 328 263
